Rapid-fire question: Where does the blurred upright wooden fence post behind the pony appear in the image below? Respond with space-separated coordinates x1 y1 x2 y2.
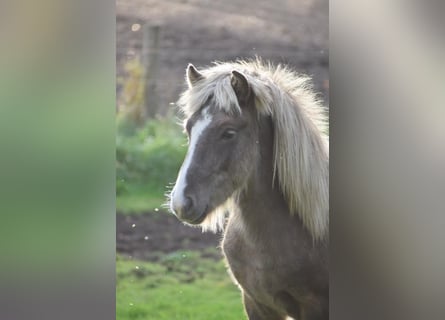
142 24 160 119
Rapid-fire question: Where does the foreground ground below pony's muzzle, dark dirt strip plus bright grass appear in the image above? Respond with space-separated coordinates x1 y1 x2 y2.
116 211 244 320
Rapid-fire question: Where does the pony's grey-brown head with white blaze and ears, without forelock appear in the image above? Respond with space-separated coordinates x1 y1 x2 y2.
170 65 258 228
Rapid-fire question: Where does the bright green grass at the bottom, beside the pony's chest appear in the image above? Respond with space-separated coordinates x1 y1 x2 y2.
116 251 245 320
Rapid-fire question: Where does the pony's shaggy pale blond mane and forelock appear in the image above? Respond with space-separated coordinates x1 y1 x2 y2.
178 59 329 240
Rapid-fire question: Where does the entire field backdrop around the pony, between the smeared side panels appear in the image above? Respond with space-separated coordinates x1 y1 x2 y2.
116 0 329 319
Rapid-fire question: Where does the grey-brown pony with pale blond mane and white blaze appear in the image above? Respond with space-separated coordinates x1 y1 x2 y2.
169 58 329 320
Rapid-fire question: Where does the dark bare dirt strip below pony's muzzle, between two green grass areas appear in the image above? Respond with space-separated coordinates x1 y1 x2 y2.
116 211 221 261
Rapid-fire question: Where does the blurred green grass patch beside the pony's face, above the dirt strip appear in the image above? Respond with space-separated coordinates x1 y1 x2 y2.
116 115 187 213
